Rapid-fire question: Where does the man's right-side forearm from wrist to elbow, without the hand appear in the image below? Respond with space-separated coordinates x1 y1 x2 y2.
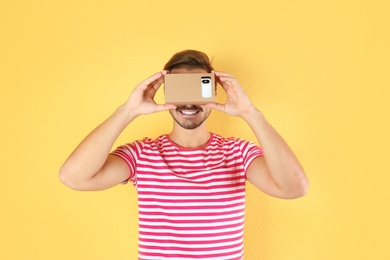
243 108 308 193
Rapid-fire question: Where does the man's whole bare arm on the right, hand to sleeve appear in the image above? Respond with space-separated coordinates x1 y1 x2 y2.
208 72 309 199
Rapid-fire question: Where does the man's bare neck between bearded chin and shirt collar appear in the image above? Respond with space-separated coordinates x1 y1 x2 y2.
169 123 210 148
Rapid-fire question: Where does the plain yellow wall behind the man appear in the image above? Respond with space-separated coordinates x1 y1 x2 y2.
0 0 390 260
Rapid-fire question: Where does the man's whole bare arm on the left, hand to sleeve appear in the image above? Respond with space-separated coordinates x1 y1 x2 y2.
60 71 174 190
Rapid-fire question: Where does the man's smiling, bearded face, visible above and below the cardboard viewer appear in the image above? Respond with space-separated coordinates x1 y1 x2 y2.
169 68 211 130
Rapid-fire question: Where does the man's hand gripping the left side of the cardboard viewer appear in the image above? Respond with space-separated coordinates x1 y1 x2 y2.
124 70 176 117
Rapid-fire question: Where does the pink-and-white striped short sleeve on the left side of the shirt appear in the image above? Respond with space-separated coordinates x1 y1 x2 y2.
111 141 143 185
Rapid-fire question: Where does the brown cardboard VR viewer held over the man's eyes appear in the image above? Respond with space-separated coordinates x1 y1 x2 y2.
164 73 216 105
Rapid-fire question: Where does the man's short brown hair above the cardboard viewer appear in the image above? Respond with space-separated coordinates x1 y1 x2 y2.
164 50 214 73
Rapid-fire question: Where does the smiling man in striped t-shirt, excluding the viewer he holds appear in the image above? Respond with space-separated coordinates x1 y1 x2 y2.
60 50 308 260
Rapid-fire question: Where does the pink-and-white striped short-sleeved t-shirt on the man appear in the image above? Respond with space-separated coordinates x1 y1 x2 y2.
112 134 262 260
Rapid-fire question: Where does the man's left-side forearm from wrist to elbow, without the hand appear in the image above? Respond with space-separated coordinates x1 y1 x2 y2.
60 105 136 182
